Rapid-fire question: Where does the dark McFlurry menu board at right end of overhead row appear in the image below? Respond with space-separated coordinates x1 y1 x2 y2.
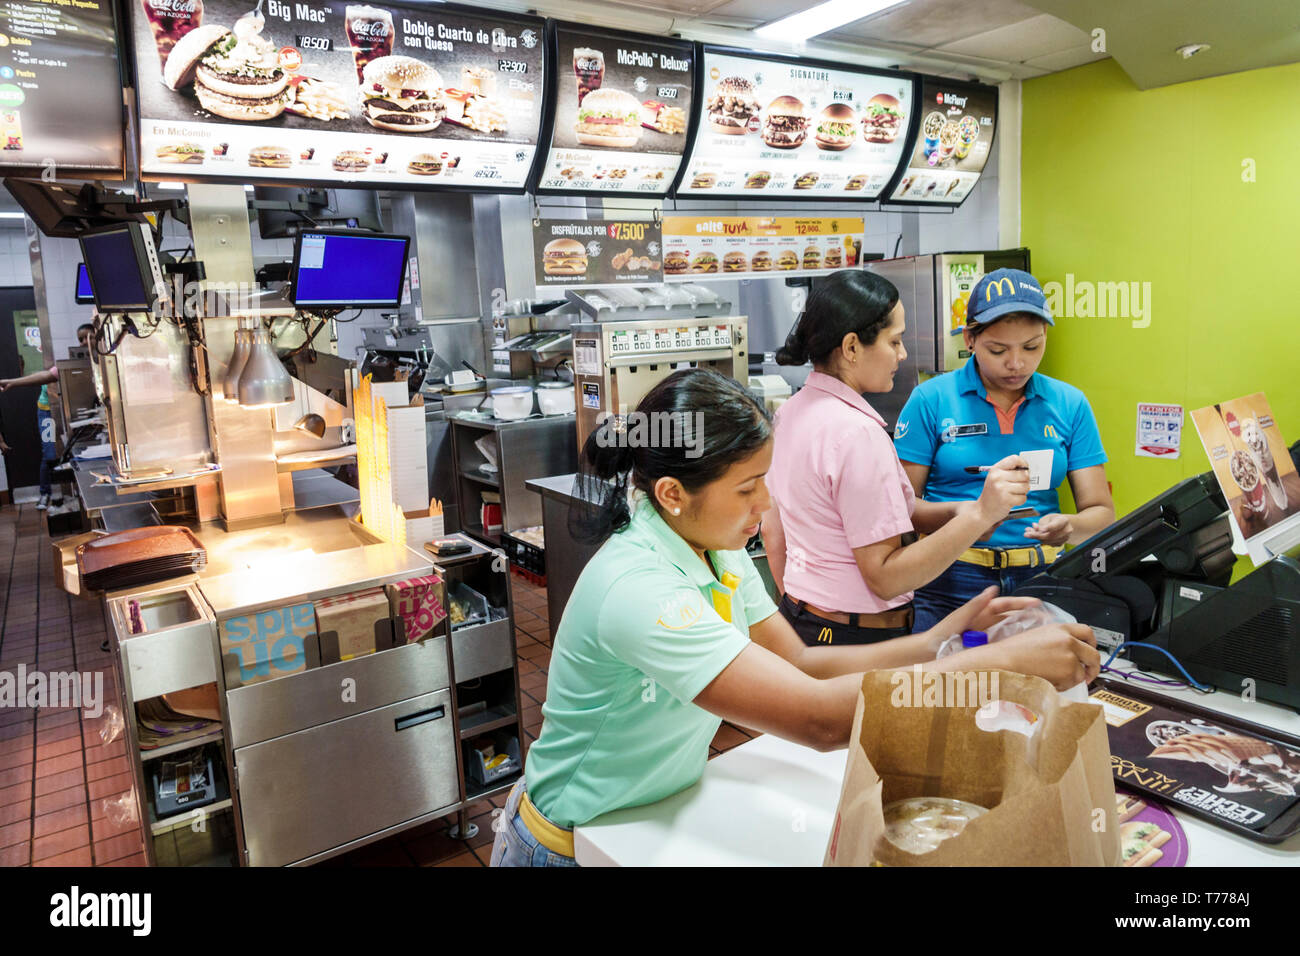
887 77 997 206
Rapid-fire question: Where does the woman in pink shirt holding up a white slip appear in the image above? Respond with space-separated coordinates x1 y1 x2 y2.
763 271 1030 646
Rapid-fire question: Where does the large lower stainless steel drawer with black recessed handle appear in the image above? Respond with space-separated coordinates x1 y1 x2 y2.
234 682 460 866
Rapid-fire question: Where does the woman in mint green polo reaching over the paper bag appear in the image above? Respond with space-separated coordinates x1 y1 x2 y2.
493 369 1100 866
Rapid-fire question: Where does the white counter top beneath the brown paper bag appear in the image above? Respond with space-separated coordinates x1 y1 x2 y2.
573 671 1300 866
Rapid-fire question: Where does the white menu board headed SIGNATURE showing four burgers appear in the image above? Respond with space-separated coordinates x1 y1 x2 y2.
676 47 913 202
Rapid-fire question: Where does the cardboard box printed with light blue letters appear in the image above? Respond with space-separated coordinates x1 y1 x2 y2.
217 604 320 691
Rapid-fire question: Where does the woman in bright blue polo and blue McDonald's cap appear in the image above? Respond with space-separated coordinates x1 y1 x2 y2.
894 269 1115 631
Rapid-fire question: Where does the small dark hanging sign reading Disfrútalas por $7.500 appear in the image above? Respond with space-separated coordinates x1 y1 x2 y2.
533 219 663 287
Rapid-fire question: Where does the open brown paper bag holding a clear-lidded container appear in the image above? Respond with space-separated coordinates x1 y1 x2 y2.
824 669 1119 866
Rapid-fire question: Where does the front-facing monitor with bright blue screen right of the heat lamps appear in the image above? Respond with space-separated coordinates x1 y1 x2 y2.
290 229 411 308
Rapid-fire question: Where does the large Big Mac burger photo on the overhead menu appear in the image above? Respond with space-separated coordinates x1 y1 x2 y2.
163 23 294 121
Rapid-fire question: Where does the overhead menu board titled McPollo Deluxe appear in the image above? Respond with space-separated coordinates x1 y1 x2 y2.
537 23 696 196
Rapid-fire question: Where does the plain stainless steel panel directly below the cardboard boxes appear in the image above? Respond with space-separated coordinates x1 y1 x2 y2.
226 637 449 748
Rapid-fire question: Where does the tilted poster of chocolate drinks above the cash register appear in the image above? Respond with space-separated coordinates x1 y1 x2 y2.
1192 392 1300 563
